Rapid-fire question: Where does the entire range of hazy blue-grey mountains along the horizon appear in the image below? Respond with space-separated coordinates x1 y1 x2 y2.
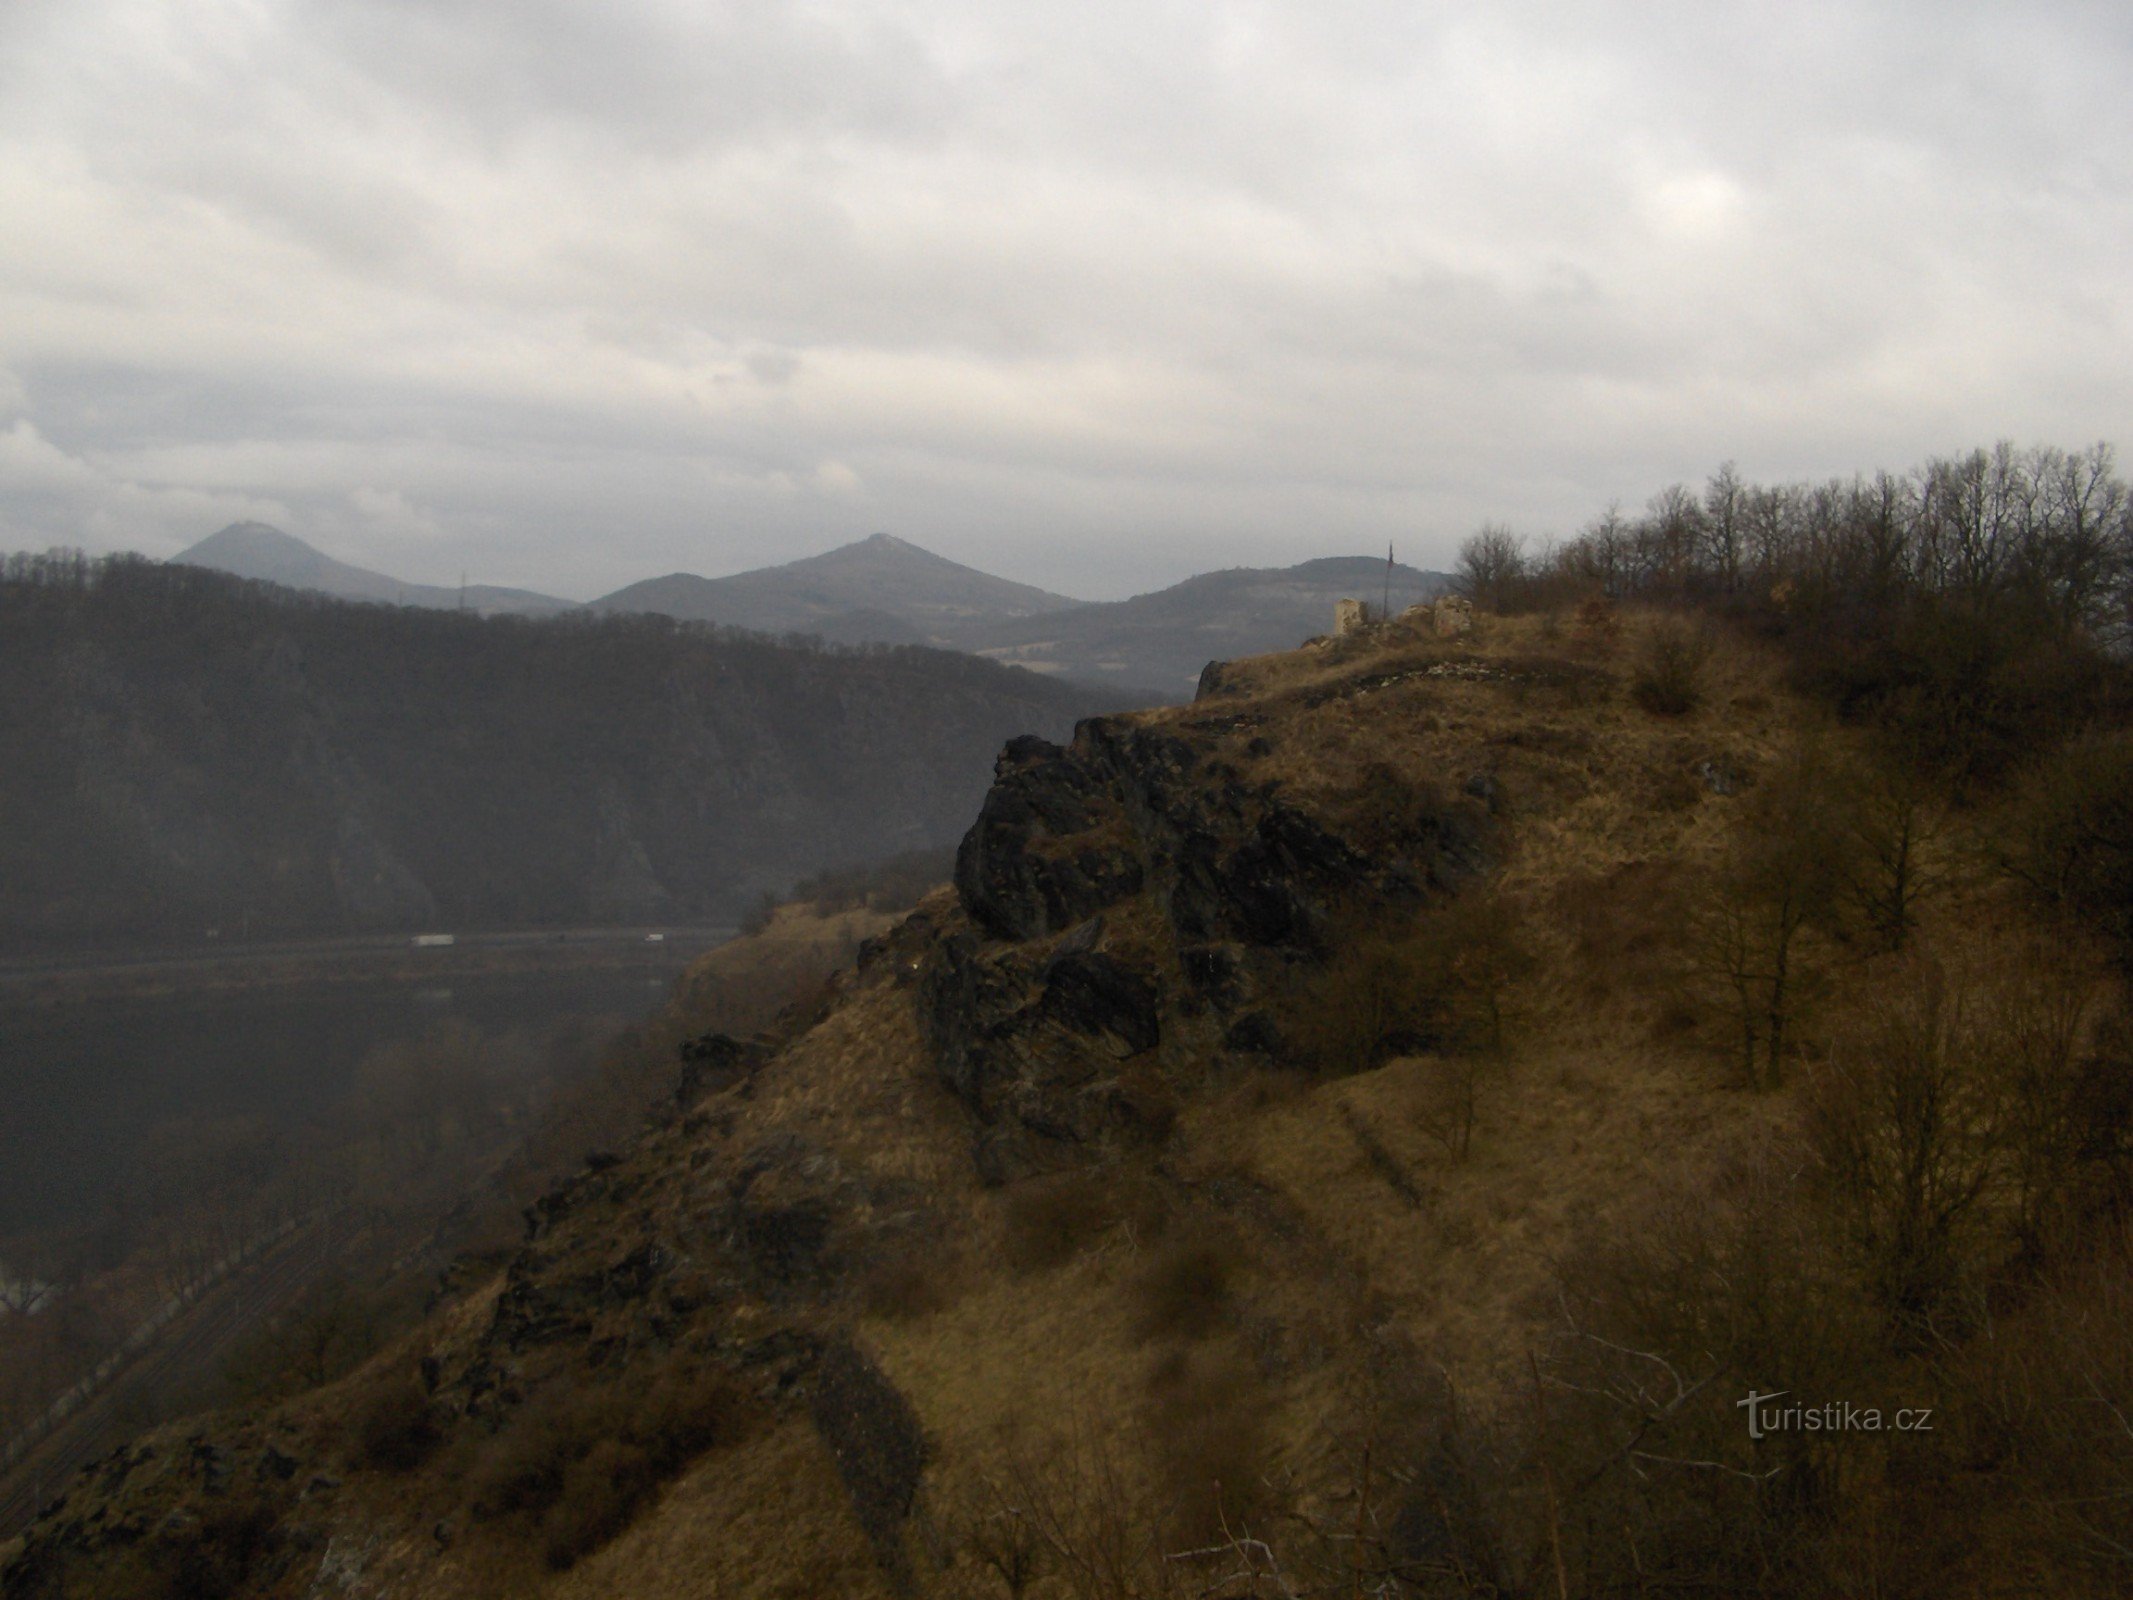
177 523 1450 700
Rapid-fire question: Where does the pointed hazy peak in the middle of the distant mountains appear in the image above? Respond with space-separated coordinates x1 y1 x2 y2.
591 533 1081 644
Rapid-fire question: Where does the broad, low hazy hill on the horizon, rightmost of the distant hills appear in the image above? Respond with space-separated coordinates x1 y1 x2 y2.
953 557 1450 700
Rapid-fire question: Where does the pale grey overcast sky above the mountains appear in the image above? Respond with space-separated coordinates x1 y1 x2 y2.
0 0 2133 597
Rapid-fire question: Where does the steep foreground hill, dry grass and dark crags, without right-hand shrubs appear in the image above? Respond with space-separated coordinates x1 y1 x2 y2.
16 605 2098 1596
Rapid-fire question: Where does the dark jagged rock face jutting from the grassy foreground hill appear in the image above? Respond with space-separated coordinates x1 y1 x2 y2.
919 717 1485 1180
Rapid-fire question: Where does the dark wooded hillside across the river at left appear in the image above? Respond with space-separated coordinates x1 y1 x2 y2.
0 557 1098 945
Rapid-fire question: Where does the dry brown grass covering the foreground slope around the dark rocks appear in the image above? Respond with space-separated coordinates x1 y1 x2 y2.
17 612 2124 1600
